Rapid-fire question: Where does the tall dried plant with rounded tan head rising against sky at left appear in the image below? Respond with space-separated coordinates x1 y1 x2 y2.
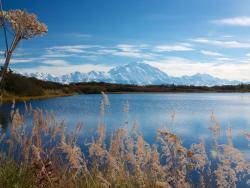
0 10 48 89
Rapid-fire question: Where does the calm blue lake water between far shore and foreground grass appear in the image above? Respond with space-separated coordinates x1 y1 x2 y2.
0 93 250 152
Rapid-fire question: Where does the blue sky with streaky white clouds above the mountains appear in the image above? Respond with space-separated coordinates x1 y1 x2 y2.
0 0 250 81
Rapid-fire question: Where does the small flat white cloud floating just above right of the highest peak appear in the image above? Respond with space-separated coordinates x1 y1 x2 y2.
155 44 194 52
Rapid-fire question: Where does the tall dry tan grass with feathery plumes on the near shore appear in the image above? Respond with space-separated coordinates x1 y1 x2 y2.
0 93 250 188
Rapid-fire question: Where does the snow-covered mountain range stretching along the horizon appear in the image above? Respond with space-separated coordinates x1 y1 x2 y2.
24 63 241 86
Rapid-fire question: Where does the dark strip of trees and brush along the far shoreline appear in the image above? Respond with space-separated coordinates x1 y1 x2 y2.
3 70 250 101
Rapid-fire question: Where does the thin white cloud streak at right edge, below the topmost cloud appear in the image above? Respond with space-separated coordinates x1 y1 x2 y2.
192 38 250 48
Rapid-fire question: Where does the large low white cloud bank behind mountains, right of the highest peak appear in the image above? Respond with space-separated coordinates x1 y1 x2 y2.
145 57 250 81
